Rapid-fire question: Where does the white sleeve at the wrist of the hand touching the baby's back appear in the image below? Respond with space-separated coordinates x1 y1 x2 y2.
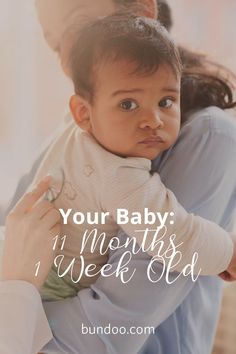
0 281 52 354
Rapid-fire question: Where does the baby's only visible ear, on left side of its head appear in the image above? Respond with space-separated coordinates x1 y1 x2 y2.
69 95 91 131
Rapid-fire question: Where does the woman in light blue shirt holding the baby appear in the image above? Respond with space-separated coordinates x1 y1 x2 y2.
3 0 236 354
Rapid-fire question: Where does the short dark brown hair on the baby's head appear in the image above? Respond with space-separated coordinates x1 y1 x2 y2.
69 13 182 102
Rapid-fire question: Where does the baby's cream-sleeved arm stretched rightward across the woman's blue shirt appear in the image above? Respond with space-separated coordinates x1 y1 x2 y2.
103 159 233 275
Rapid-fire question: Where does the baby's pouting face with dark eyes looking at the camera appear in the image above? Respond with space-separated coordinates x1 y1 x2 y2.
86 61 180 160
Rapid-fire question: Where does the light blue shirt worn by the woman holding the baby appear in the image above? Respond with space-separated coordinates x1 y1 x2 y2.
3 107 236 354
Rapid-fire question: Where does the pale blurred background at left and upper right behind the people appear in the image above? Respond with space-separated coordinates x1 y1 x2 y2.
0 0 236 208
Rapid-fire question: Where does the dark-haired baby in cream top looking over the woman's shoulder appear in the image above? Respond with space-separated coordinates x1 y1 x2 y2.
30 14 233 300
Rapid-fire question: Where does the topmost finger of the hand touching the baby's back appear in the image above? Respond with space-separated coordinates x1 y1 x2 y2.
12 176 51 215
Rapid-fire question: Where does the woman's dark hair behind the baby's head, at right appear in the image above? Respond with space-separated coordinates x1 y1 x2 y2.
111 0 236 122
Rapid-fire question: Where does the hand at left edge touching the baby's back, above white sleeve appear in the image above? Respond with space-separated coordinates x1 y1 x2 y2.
1 177 61 289
